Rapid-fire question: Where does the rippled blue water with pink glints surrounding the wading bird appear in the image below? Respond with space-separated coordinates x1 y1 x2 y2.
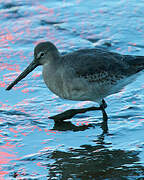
0 0 144 180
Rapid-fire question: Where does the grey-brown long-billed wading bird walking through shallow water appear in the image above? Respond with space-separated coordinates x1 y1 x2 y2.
6 42 144 129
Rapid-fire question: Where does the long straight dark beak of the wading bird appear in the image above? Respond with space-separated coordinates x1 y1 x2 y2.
6 60 38 90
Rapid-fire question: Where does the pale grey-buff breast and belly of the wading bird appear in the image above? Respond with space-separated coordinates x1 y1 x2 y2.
43 65 88 100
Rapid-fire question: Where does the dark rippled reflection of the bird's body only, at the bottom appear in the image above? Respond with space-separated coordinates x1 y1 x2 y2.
46 143 144 180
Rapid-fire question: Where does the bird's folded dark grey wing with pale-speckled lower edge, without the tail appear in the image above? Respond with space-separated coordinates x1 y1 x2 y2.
63 49 132 82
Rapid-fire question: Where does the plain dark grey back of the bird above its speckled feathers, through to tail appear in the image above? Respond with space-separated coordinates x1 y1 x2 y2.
62 48 144 77
